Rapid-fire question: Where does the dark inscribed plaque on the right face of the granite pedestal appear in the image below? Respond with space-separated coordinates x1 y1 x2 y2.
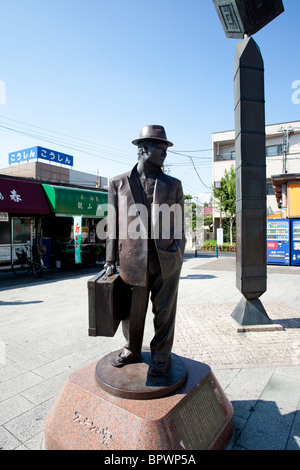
172 379 226 450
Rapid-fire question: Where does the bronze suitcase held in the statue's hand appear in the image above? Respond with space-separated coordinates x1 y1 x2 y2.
88 269 131 337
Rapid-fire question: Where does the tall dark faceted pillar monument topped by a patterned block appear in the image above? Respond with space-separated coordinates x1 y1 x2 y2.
213 0 284 326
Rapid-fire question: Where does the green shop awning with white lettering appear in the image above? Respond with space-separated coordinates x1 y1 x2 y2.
42 184 107 218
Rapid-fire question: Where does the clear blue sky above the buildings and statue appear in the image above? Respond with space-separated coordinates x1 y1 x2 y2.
0 0 300 200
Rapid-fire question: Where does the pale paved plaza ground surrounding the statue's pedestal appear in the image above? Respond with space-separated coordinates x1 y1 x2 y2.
0 253 300 450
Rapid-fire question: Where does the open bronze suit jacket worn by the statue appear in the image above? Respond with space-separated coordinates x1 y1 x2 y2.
106 166 185 286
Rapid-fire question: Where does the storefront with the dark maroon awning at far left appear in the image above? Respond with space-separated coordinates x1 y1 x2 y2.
0 177 50 269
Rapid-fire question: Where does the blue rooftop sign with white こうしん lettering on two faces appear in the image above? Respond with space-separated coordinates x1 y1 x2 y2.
8 147 73 166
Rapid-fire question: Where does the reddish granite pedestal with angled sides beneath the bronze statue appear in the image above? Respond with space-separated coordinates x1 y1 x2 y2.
43 352 233 451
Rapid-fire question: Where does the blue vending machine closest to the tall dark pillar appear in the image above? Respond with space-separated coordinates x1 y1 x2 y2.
267 219 290 265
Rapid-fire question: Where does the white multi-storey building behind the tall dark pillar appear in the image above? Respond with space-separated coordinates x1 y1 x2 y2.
212 121 300 234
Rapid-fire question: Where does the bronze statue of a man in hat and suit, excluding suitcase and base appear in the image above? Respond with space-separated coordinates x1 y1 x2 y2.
105 125 185 376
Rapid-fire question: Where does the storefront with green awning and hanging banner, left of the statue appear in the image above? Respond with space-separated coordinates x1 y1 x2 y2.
42 184 107 269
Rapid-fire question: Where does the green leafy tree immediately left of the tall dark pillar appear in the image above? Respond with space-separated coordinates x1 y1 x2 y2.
213 166 236 245
